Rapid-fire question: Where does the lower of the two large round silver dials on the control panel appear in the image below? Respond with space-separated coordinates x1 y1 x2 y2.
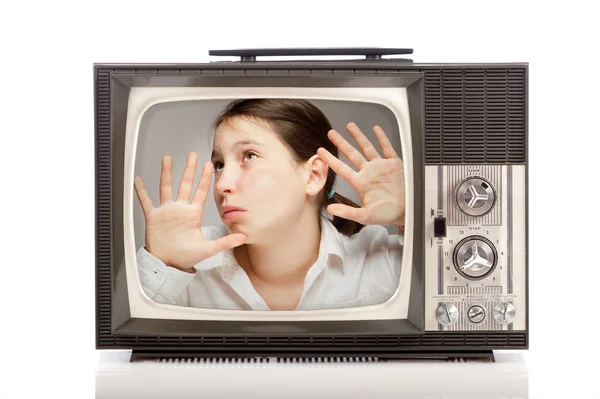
454 236 497 280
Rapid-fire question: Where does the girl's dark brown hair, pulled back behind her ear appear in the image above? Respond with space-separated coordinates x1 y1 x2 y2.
213 99 364 235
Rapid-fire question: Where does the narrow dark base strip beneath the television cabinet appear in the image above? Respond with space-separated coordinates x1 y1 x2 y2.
129 349 496 363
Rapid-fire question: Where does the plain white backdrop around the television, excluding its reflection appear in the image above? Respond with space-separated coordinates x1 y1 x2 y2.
0 0 600 398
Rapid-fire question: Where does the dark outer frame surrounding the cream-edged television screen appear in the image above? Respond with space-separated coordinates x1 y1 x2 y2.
94 64 424 342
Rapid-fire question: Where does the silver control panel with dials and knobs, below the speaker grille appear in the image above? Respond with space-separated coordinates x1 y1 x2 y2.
425 165 527 331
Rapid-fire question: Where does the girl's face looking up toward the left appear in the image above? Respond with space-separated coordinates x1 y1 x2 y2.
211 118 308 244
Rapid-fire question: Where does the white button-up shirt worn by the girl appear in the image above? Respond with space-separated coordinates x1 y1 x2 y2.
137 213 404 310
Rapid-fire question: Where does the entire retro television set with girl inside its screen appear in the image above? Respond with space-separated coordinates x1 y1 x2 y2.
93 48 529 361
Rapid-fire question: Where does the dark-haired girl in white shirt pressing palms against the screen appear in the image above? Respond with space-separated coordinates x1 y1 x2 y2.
135 99 404 310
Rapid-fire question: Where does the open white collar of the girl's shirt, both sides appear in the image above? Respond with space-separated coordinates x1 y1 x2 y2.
215 210 346 284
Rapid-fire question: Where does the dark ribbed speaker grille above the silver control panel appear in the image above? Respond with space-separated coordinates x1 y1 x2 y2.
425 67 527 164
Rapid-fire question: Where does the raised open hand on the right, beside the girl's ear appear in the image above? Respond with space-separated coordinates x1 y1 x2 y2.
317 122 405 226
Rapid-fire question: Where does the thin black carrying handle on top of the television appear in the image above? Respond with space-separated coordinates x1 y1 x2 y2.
208 47 413 62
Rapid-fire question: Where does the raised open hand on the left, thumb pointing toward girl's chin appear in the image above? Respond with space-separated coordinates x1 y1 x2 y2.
134 152 246 273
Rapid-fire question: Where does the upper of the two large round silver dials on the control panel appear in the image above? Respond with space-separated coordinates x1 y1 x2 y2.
455 177 496 216
